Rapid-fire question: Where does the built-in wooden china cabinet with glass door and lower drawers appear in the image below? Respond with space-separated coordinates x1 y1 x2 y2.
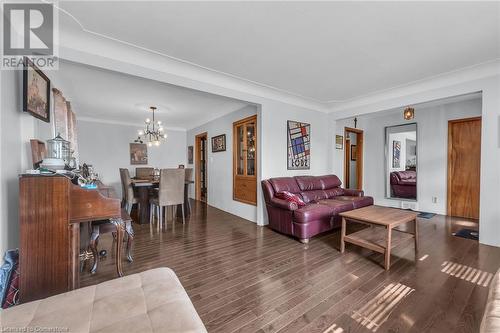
233 115 257 205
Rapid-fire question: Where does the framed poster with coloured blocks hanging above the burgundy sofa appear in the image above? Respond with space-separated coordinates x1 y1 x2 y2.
287 120 311 170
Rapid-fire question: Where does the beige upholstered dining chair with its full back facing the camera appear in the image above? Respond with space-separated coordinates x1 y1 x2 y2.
149 169 186 228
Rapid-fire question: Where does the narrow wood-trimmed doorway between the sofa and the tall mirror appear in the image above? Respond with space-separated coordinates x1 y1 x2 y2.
344 127 363 190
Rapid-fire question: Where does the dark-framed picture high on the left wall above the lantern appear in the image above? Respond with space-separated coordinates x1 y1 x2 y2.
23 57 50 123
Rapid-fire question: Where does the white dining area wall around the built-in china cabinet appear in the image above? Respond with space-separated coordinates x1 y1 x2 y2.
187 105 260 222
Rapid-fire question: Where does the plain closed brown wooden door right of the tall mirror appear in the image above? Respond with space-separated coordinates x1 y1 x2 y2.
448 117 481 219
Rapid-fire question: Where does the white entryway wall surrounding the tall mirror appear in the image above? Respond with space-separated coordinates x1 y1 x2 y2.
335 99 481 214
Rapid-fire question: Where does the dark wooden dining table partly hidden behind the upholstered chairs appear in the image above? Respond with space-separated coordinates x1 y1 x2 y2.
131 178 194 224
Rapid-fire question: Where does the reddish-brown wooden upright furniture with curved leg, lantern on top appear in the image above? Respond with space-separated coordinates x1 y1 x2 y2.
19 175 124 303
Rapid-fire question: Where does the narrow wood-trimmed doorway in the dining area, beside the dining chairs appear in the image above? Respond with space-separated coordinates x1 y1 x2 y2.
194 132 208 203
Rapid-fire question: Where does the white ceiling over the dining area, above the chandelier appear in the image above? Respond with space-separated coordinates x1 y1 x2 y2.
52 60 248 129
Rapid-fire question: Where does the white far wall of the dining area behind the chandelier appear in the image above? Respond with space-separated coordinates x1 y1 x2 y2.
77 117 187 194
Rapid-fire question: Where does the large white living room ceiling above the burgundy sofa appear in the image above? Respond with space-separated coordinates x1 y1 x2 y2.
60 1 500 101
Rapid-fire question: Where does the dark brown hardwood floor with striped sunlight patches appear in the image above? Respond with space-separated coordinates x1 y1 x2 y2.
81 203 500 333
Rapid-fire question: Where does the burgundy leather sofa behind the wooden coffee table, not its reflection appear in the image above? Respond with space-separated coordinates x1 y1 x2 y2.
262 175 373 243
